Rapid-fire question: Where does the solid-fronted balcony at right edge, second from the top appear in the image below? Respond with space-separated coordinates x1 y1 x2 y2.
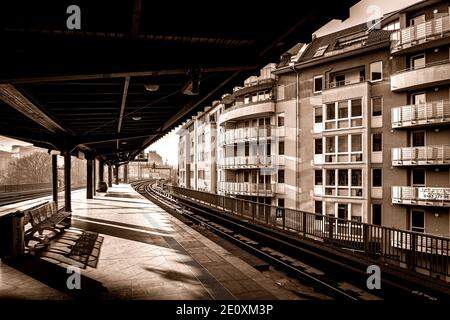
391 59 450 92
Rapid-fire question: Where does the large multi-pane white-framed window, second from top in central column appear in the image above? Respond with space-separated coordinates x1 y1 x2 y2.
325 134 362 163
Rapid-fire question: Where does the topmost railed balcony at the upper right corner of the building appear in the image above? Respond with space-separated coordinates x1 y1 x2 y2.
391 15 450 53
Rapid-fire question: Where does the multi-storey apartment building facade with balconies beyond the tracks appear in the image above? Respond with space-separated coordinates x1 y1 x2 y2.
180 0 450 236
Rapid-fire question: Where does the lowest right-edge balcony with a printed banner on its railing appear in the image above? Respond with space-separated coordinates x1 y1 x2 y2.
392 186 450 207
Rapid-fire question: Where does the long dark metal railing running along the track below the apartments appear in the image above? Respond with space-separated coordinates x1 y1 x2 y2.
169 186 450 277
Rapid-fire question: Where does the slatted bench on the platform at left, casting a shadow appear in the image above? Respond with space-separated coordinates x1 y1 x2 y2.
23 201 70 247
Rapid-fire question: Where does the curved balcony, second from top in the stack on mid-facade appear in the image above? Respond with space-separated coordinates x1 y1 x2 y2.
218 126 277 146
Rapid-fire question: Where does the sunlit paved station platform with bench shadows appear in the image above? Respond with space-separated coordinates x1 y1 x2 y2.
0 184 299 300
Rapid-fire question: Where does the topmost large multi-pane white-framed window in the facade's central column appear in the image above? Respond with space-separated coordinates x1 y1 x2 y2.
325 98 362 130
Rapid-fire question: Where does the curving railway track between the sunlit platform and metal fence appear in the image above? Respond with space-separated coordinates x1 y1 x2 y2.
132 181 379 301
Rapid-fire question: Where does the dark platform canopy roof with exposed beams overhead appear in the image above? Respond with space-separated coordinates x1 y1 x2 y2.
0 0 357 164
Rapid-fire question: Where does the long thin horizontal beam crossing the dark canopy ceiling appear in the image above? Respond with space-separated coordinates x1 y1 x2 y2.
0 65 257 85
